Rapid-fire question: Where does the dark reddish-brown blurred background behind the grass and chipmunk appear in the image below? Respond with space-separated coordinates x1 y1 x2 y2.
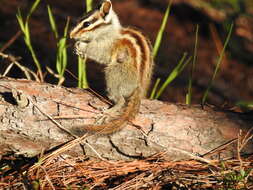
0 0 253 108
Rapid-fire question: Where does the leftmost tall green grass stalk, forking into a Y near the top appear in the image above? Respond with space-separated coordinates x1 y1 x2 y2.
16 0 44 82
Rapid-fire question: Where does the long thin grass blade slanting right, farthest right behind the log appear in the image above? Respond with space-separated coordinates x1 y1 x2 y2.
201 23 234 105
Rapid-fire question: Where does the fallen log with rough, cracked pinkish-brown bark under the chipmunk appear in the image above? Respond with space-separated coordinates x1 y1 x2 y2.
0 78 253 160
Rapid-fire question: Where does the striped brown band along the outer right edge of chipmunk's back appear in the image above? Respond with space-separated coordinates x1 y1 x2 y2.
122 28 152 92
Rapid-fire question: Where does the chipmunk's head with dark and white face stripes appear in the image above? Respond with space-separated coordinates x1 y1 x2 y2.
70 0 121 43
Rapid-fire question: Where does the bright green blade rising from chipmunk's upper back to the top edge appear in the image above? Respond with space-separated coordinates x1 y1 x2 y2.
153 0 172 59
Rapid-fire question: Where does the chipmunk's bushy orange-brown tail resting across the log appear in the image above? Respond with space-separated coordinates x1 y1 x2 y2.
71 88 141 135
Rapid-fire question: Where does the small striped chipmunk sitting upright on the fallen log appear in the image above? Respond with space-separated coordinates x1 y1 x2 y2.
70 0 153 134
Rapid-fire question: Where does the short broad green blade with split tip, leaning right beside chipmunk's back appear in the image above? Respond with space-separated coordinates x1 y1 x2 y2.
155 53 191 99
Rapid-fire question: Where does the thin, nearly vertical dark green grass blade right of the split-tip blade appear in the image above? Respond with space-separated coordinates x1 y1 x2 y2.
186 25 199 105
